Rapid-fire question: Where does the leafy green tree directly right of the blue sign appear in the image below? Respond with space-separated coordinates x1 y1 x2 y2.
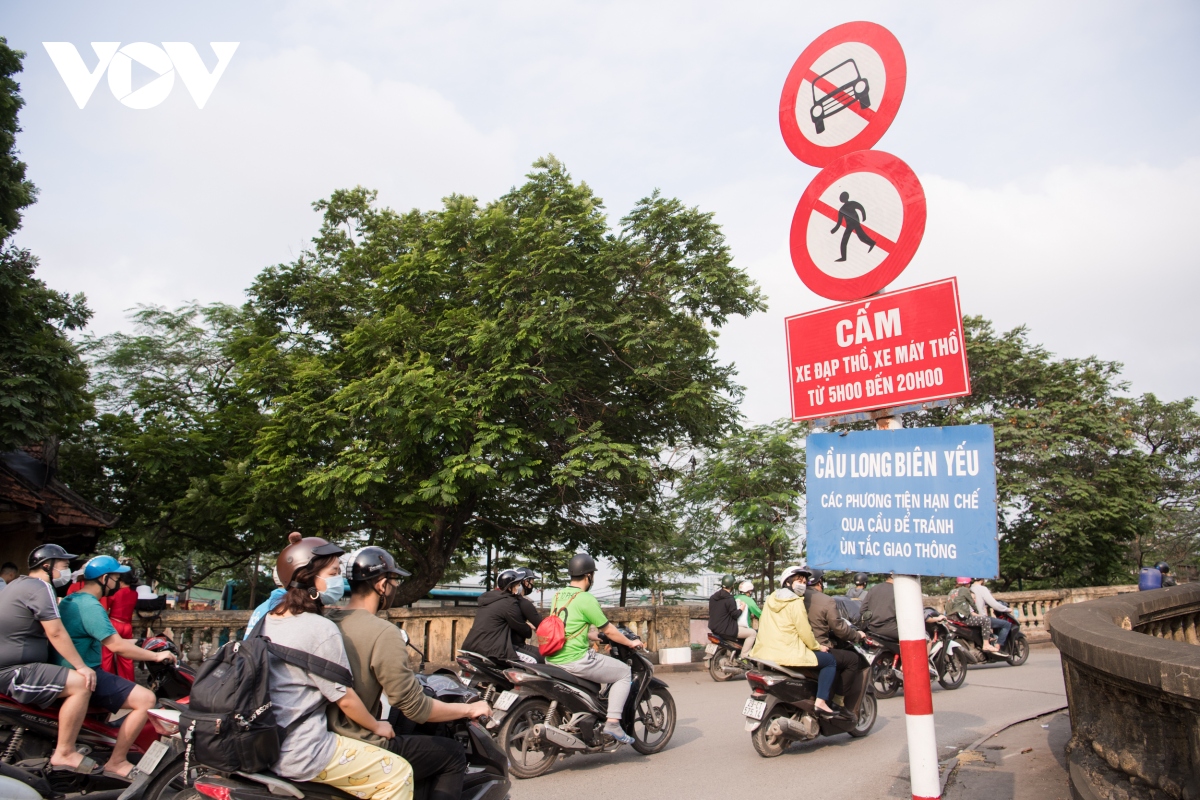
908 317 1154 587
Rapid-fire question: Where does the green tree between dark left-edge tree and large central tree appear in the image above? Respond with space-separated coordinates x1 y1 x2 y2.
61 303 277 588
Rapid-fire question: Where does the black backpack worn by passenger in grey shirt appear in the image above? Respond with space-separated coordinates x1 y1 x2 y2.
179 618 354 775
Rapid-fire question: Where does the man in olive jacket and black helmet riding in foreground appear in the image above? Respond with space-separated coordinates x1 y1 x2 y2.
325 547 491 800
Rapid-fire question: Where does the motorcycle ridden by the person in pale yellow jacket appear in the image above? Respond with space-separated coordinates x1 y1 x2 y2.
742 643 878 758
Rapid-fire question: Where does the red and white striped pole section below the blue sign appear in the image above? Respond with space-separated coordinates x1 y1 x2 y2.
892 575 942 800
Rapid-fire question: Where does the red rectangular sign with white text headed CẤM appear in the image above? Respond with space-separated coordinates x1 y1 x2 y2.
784 278 971 420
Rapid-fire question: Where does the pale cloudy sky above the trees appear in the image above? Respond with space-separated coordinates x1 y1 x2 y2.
7 0 1200 423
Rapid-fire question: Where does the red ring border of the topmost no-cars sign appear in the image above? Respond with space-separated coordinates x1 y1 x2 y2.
779 22 908 167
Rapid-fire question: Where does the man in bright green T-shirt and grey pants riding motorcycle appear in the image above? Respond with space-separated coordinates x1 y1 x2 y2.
546 553 642 745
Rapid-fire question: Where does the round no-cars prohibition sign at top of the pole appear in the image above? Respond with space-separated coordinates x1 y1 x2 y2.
779 22 907 167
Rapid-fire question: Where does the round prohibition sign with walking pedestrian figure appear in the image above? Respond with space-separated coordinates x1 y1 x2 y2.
790 150 925 300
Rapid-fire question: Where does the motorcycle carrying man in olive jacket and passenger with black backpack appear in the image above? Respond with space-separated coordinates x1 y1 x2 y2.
138 673 512 800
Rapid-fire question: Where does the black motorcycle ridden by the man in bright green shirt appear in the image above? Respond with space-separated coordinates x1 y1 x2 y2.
493 628 676 778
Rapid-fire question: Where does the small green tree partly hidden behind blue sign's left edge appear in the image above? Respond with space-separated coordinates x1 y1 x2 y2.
679 420 809 591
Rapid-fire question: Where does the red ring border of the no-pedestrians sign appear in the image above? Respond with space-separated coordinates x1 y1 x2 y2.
788 150 926 300
